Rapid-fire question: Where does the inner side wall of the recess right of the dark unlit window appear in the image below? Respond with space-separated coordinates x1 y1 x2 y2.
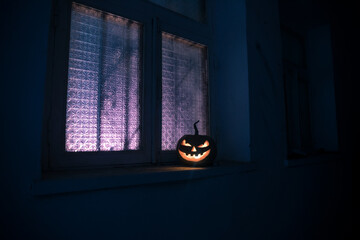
306 25 338 151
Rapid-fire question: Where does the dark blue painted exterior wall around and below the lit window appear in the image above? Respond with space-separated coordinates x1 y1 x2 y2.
0 0 352 239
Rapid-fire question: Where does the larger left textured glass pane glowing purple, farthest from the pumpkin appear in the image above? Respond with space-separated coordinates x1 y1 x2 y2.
66 3 142 152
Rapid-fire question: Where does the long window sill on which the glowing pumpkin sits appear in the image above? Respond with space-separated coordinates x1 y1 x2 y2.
31 162 256 196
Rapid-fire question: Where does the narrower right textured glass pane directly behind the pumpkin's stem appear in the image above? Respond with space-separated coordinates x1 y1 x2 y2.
161 33 208 150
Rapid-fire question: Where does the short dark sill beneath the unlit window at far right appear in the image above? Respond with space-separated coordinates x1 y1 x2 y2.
285 153 340 167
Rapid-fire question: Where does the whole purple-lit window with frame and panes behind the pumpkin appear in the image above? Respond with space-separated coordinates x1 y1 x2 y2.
43 1 211 170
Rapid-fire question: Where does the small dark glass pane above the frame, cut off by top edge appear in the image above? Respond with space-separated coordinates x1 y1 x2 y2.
149 0 205 22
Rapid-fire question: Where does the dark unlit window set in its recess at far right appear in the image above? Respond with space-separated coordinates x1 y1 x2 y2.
282 25 338 159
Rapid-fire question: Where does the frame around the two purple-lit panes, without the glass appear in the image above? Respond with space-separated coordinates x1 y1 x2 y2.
42 0 215 171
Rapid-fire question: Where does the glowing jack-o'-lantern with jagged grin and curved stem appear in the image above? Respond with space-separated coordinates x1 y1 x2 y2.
176 121 216 166
